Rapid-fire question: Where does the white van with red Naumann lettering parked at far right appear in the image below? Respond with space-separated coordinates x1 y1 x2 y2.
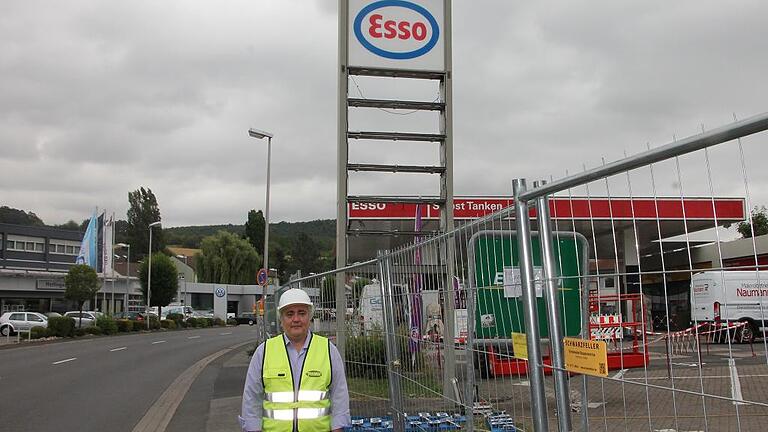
691 271 768 341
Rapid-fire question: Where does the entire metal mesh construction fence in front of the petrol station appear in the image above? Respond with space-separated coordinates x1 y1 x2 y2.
277 114 768 431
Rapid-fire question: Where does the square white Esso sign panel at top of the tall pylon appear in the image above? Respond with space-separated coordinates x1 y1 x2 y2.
348 0 445 71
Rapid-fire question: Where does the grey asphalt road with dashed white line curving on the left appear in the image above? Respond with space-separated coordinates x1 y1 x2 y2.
0 325 256 432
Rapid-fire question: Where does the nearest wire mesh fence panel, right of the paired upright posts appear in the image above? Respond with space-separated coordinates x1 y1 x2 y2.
520 116 768 432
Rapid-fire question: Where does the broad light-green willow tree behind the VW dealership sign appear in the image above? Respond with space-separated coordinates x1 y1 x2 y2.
195 231 261 285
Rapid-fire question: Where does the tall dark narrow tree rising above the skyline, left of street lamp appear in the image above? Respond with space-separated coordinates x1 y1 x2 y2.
126 187 165 258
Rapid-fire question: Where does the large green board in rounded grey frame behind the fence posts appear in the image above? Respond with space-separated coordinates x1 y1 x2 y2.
469 231 588 340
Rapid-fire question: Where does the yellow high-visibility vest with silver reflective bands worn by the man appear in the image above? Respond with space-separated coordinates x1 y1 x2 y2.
261 334 331 432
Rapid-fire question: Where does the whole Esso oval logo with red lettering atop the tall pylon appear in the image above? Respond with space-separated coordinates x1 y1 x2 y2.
353 0 440 60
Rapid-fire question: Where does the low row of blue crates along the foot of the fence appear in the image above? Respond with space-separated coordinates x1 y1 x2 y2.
344 412 466 432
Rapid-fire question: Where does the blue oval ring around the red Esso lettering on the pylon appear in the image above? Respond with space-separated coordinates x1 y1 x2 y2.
353 0 440 60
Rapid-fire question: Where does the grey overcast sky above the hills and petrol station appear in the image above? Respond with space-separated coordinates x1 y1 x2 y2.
0 0 768 226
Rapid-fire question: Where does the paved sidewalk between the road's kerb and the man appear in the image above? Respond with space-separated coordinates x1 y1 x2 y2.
166 344 253 432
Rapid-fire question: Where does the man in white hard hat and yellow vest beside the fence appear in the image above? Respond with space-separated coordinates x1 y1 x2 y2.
240 288 351 432
